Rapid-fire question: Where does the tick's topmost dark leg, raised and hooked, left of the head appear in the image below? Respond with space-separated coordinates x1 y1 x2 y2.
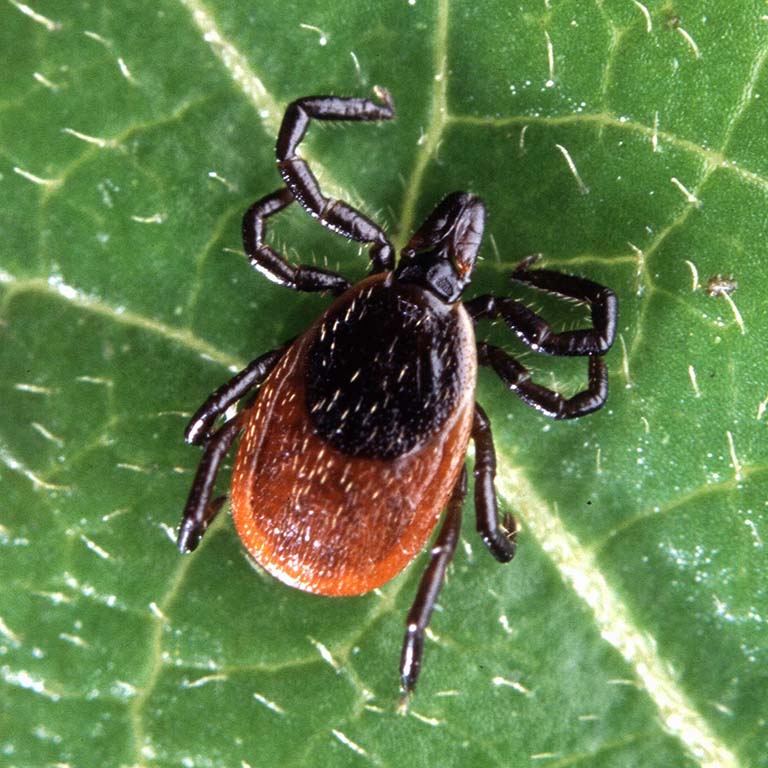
275 88 395 272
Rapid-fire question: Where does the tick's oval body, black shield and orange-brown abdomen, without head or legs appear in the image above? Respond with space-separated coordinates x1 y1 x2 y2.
232 274 477 595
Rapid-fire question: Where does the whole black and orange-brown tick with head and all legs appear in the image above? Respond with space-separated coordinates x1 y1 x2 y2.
178 88 617 693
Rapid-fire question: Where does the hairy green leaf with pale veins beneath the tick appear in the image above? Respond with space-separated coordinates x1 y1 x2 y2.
0 0 768 768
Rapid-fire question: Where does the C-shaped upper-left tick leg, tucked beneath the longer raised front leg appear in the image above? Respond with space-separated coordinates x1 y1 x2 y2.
243 188 350 295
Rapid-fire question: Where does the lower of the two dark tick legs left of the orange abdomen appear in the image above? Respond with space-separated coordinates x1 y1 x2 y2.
176 416 242 552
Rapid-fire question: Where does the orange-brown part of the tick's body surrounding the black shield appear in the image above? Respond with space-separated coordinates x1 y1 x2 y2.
232 275 476 595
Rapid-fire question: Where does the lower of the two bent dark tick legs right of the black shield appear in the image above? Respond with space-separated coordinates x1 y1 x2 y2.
477 342 608 419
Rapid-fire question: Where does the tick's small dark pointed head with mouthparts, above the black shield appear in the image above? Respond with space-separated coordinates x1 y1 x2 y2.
395 192 485 303
